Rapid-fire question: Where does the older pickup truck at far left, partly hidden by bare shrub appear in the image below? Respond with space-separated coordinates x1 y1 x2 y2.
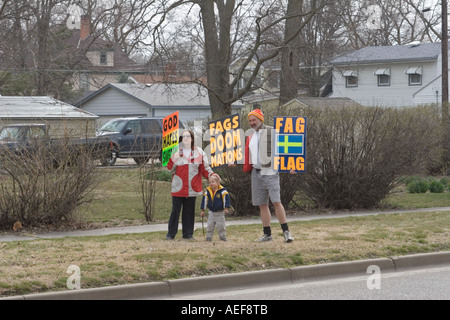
0 124 111 163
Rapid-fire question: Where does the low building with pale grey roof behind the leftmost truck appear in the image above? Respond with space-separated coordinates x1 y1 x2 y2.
0 97 98 138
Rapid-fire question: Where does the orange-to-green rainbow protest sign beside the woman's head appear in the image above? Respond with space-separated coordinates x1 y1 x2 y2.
161 111 180 167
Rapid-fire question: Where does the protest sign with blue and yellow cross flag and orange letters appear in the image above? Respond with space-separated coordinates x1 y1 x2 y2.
273 117 307 172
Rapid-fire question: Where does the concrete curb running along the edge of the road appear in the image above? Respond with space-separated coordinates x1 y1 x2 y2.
4 251 450 300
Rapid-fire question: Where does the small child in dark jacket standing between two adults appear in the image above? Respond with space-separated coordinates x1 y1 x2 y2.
201 174 230 241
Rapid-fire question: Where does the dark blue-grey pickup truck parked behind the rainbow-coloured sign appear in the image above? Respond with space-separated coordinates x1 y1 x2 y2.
97 117 184 166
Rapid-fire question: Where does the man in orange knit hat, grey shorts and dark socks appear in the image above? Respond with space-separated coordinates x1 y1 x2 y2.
244 109 294 243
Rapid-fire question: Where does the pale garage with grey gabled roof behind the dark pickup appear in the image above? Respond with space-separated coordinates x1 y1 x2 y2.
75 83 242 126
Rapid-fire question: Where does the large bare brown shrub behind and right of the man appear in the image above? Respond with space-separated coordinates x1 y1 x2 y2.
213 103 442 211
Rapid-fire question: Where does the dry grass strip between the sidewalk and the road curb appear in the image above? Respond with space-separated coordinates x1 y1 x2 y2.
0 212 450 296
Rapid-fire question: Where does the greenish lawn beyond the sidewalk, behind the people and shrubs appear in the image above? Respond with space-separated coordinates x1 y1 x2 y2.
80 169 450 227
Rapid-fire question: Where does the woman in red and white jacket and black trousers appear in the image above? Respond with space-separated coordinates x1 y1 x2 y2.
166 130 214 240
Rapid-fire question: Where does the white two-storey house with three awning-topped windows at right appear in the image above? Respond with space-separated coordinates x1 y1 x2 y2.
329 43 442 107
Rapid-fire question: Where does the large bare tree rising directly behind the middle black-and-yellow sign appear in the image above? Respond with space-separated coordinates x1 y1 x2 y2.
154 0 327 118
